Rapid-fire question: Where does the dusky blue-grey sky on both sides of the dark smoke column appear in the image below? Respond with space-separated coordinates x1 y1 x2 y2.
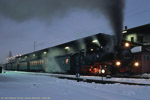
0 0 150 63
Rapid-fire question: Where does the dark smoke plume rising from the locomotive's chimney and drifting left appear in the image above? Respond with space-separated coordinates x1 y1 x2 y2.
0 0 125 44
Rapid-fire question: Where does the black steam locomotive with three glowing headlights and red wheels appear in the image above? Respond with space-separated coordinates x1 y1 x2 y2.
72 42 140 75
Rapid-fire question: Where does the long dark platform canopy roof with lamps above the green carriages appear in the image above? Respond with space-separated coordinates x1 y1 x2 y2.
17 33 114 58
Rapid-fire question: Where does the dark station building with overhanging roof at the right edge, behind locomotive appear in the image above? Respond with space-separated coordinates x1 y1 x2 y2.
122 24 150 73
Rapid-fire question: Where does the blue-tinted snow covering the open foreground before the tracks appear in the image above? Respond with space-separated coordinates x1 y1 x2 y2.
0 72 150 100
